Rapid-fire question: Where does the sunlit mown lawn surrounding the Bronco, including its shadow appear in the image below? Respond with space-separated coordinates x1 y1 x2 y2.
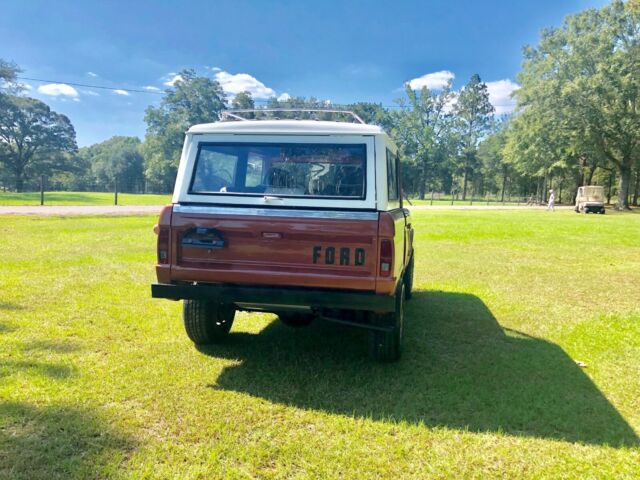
0 210 640 479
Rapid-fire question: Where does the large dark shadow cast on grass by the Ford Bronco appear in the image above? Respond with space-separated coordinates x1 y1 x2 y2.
201 291 639 447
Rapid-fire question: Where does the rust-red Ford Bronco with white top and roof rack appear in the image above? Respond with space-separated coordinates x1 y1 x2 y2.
151 110 414 361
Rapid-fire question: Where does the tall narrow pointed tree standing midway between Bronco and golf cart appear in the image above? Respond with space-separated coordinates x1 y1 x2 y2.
453 73 494 200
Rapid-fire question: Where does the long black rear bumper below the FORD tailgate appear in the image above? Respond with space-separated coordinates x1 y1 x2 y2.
151 283 395 313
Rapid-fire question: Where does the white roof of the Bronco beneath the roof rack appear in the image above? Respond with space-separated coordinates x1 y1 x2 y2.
187 120 384 135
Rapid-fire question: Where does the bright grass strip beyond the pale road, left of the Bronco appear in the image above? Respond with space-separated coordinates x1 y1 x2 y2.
0 192 171 205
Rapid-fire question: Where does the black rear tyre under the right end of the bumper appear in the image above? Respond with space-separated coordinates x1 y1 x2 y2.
369 282 405 362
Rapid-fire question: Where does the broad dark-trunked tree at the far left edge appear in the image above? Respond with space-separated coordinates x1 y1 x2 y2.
0 94 77 192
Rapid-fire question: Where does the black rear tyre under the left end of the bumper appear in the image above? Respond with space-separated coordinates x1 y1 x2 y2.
182 300 236 345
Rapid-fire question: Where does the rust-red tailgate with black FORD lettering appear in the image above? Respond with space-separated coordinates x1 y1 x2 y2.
171 205 378 291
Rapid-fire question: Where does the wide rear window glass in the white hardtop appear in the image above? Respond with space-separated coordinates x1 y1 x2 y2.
189 143 367 199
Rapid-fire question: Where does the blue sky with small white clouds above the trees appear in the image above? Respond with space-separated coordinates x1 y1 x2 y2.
0 0 607 146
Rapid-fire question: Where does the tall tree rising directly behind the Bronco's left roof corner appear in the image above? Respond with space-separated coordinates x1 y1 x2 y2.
144 70 226 191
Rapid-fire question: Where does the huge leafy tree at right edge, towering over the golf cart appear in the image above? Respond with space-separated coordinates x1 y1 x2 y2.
516 0 640 209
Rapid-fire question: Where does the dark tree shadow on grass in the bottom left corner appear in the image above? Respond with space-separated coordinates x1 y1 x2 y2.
0 402 133 480
